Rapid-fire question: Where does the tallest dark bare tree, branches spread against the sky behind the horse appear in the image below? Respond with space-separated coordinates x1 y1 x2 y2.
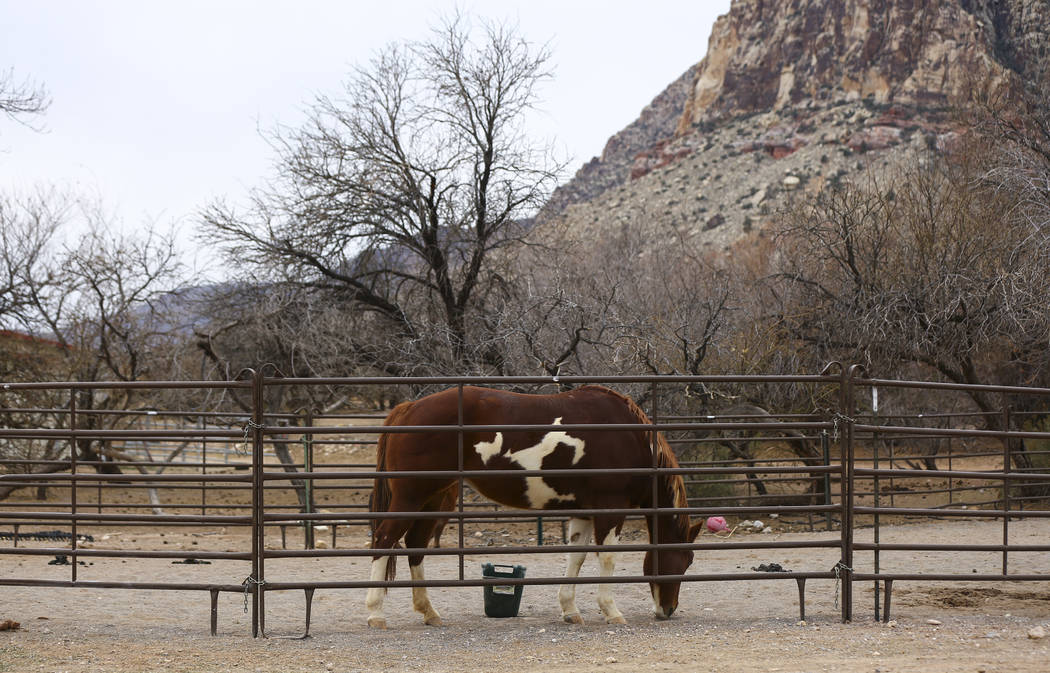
203 18 560 373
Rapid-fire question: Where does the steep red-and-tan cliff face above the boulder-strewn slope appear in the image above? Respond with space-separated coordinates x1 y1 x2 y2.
677 0 1050 128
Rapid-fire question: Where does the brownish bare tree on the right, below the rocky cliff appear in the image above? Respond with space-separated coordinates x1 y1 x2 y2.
775 147 1050 430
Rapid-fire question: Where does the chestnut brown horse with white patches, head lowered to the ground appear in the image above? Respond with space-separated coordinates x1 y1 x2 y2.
365 385 702 628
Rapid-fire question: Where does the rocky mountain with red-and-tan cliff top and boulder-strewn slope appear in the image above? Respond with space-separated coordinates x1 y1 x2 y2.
542 0 1050 247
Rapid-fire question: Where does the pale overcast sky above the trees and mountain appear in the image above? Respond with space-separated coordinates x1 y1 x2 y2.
0 0 730 270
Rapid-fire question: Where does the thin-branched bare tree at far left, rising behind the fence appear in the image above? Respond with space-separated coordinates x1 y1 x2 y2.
0 199 184 496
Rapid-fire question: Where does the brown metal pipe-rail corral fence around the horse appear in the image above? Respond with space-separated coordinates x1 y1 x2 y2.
0 366 1050 635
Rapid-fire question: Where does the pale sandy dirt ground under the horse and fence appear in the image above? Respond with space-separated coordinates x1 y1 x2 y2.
0 520 1050 673
